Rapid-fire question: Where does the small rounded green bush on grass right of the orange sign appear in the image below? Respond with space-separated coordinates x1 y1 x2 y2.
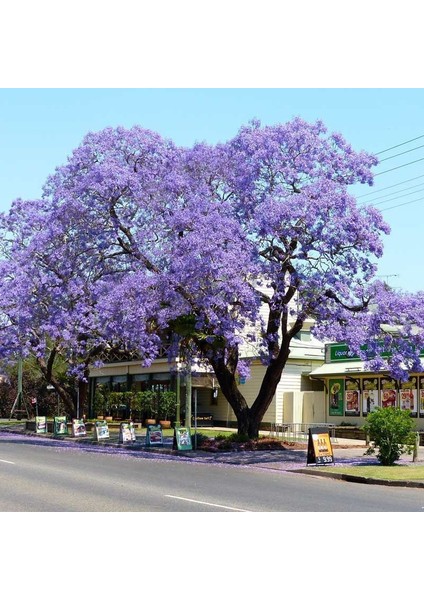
363 407 415 466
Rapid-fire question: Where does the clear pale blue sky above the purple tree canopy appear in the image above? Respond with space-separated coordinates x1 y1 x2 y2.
0 88 424 291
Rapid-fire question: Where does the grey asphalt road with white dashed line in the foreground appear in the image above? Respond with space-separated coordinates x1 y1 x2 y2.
0 433 424 512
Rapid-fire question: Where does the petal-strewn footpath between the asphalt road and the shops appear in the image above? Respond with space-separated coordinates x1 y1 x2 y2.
0 423 424 488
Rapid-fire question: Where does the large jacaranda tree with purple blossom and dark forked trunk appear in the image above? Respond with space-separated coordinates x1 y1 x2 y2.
2 119 424 437
